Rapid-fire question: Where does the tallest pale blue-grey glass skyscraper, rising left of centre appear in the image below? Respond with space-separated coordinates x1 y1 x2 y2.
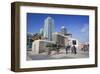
43 17 54 41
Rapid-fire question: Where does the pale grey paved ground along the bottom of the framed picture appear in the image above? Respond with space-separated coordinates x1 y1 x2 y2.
27 49 89 60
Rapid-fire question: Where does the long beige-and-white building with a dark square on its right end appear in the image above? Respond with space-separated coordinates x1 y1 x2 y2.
52 32 80 48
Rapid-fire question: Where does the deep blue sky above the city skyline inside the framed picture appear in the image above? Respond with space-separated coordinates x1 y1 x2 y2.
27 13 89 42
